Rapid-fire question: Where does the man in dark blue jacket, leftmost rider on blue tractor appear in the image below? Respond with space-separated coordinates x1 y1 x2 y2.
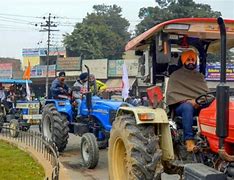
50 71 69 99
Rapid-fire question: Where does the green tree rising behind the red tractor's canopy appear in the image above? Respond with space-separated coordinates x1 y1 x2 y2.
136 0 221 34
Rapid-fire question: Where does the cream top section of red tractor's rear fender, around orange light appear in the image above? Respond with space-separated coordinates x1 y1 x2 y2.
116 106 169 124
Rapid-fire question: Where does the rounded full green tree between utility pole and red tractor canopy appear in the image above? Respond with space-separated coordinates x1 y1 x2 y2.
64 4 130 59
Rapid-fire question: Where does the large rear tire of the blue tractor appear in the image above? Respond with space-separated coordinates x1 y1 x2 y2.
41 104 69 152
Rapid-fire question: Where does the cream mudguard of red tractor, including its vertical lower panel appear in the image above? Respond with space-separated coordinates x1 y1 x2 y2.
116 106 174 161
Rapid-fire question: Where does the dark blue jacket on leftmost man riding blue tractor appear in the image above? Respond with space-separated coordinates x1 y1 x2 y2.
50 78 68 98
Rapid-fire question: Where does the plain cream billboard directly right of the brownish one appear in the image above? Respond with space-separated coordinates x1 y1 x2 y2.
82 59 107 79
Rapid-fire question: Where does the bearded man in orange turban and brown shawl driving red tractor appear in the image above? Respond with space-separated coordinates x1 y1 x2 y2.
166 50 208 152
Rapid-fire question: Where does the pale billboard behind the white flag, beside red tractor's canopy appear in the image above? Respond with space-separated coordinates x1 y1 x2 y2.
108 59 138 77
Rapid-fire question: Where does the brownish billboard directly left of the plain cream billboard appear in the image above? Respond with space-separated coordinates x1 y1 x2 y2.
56 57 81 71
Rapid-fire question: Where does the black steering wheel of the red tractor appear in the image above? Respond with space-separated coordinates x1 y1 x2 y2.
195 92 216 108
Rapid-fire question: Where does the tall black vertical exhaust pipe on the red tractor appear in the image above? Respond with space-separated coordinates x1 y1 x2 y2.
216 17 229 150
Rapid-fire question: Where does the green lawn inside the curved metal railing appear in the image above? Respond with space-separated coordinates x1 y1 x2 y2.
0 140 45 180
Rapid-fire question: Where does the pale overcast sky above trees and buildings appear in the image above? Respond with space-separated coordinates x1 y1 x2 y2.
0 0 234 59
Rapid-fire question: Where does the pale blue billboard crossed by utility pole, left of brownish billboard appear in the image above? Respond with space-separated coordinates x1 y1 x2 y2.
31 65 56 78
